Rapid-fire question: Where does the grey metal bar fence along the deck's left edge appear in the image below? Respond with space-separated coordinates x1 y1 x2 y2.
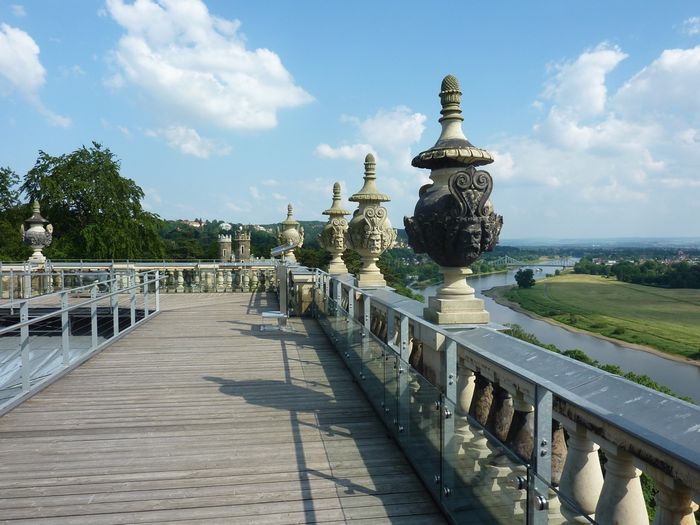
0 271 164 415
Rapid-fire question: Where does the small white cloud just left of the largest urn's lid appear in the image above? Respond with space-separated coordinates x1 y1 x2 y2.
315 106 426 171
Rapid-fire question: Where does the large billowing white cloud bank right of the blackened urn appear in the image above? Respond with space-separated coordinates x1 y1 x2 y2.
488 44 700 237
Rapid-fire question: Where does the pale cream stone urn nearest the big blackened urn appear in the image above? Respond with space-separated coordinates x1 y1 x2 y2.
345 153 396 288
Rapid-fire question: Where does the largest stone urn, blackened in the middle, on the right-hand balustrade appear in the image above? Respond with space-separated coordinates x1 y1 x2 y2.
404 75 503 324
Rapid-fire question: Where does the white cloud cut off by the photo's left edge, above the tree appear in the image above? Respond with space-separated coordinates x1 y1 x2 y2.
0 24 71 128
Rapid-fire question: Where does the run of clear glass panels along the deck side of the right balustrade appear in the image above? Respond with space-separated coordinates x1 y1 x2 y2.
316 296 530 524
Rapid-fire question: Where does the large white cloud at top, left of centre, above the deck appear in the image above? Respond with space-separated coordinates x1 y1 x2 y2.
107 0 312 129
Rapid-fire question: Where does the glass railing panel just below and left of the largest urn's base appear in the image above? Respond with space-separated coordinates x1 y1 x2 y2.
397 358 442 498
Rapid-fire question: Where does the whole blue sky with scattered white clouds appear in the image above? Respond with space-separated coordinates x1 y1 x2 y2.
0 0 700 239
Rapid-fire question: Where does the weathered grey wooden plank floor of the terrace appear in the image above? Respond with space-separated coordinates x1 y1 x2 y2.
0 294 443 525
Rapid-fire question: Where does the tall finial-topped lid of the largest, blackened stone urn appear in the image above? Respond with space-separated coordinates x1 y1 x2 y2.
411 75 493 169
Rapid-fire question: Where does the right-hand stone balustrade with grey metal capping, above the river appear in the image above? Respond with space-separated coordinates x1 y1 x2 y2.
308 272 700 525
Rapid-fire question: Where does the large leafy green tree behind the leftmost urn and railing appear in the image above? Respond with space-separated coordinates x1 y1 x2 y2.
21 142 164 259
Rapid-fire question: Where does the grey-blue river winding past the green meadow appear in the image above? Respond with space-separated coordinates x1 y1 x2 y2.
415 266 700 401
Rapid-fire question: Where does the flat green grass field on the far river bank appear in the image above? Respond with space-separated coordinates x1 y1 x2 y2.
504 274 700 360
